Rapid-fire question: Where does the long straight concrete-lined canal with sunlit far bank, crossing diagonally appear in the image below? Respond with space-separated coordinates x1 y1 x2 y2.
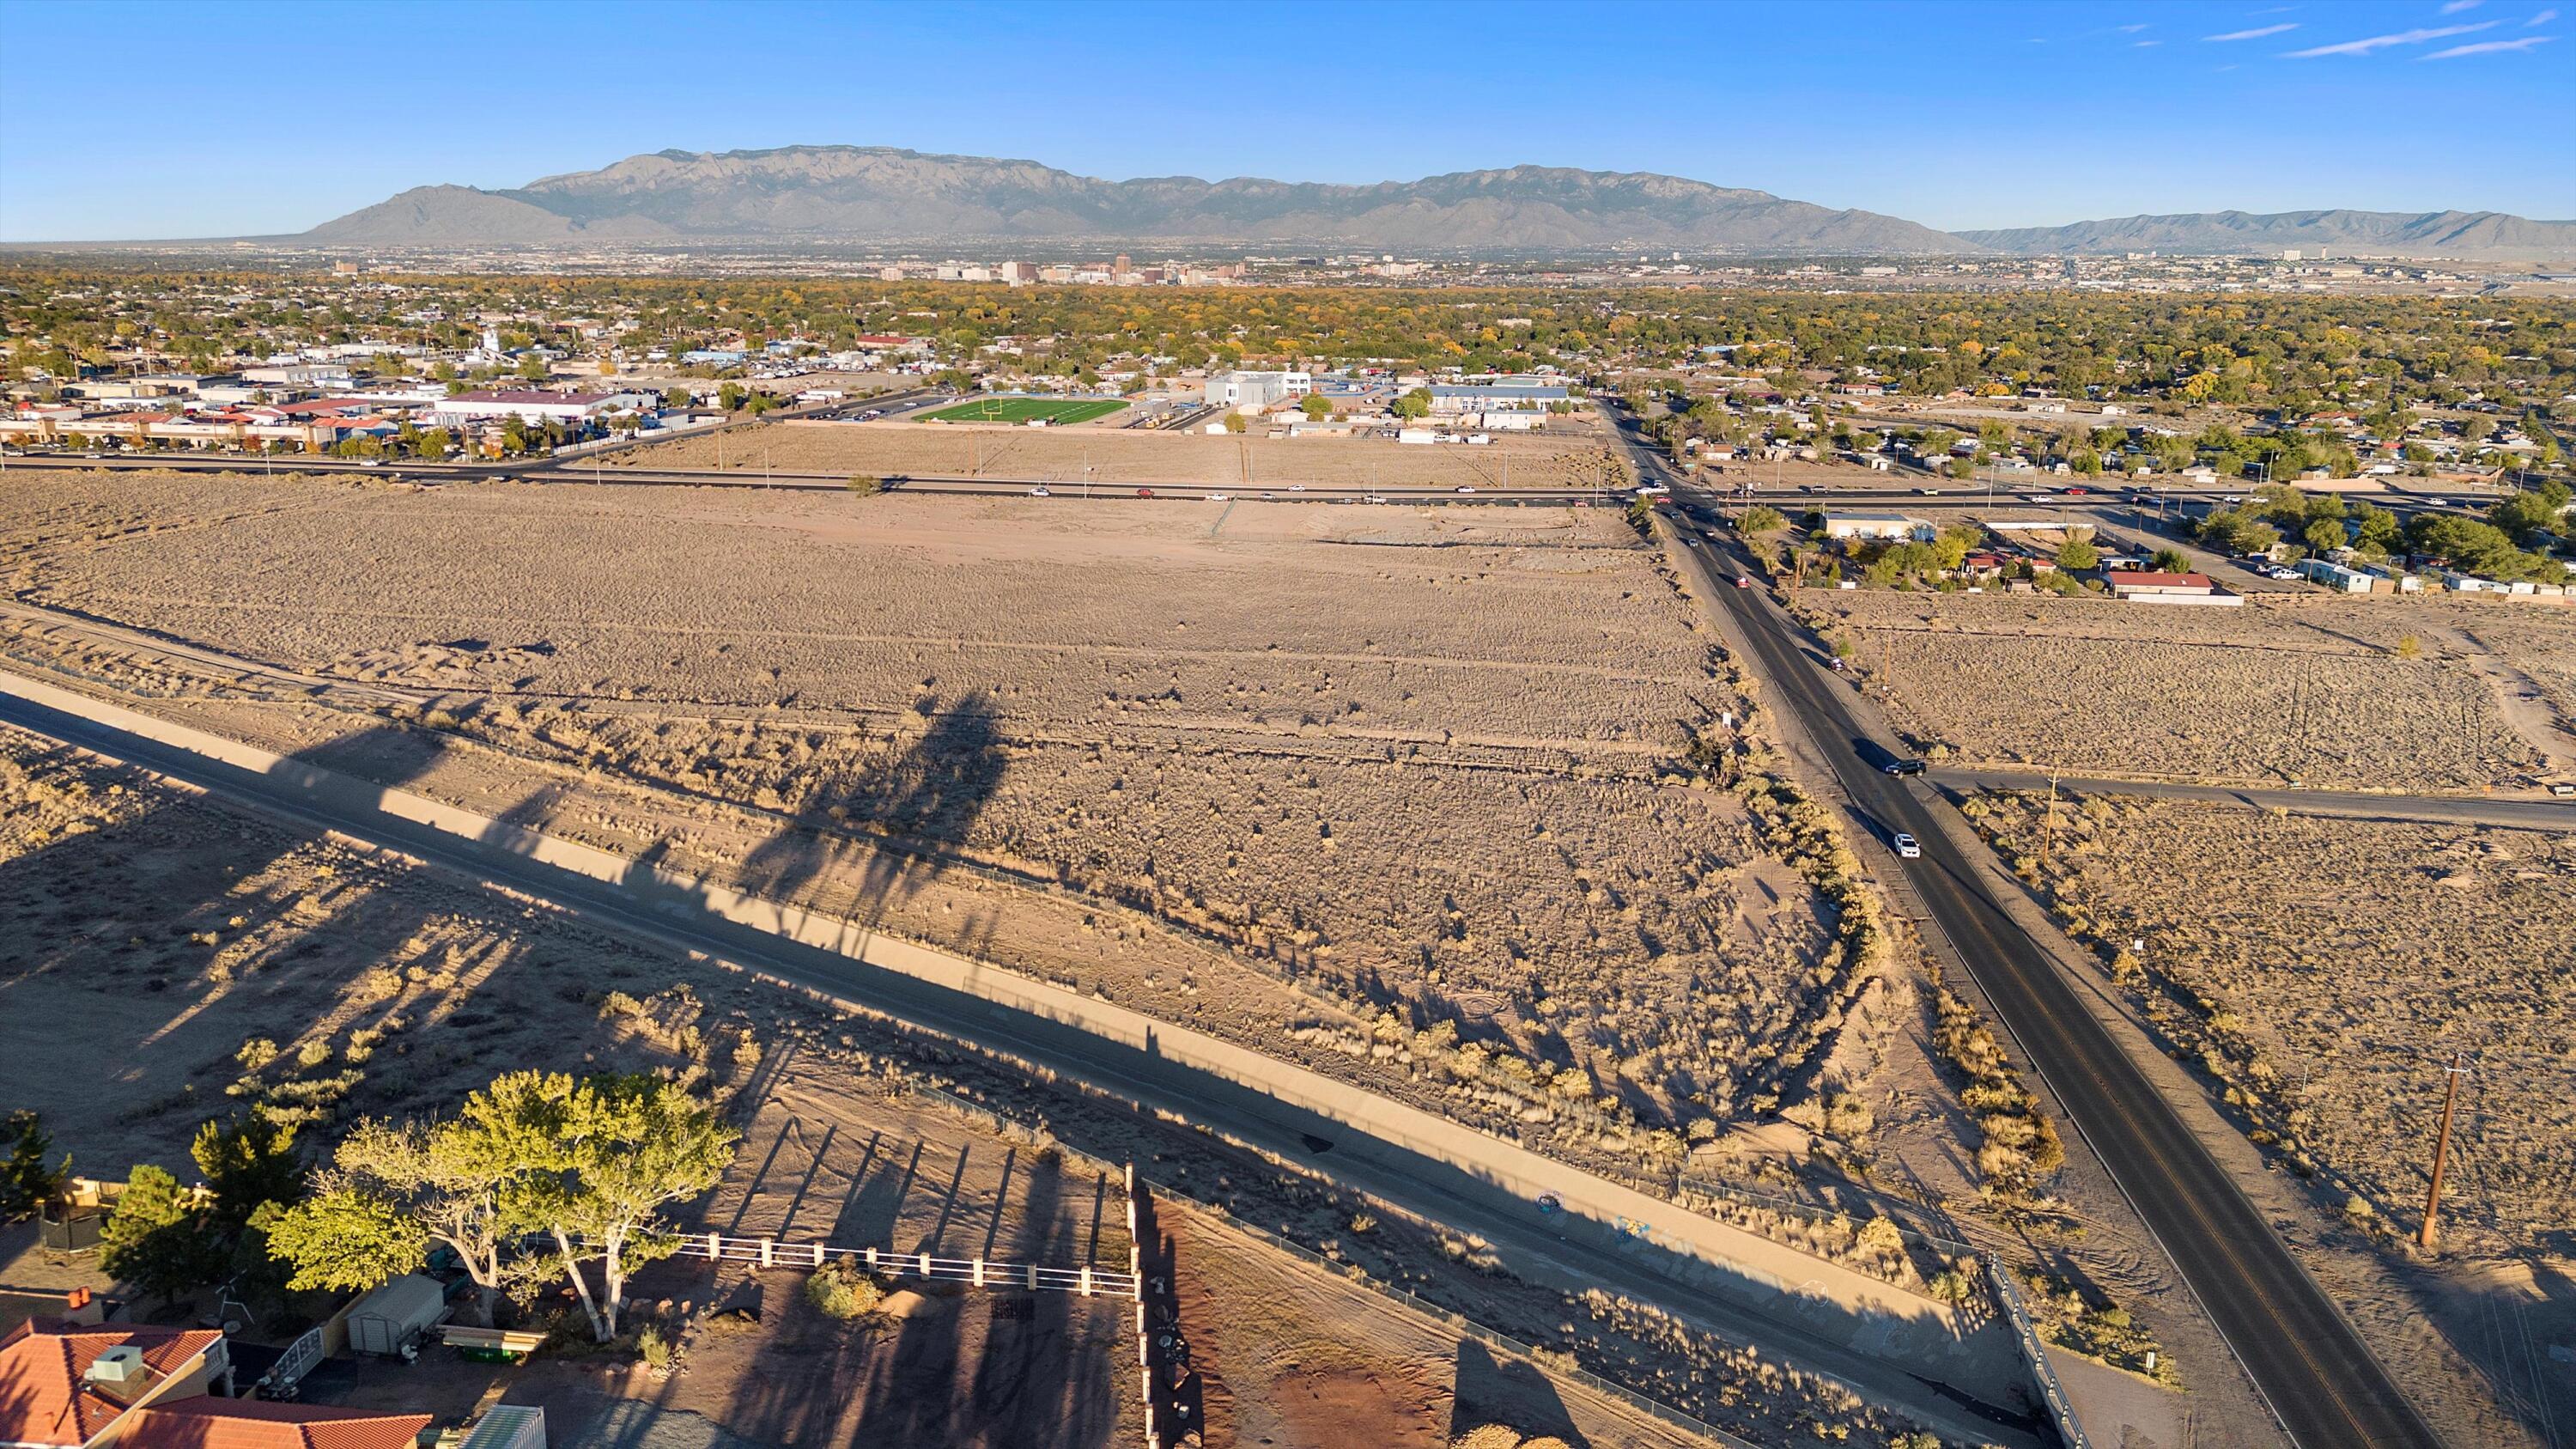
0 673 2040 1449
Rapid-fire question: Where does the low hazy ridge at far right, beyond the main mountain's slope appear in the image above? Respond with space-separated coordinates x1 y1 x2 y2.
1958 211 2576 260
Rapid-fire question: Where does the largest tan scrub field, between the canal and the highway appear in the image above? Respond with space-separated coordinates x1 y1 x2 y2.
5 474 1870 1163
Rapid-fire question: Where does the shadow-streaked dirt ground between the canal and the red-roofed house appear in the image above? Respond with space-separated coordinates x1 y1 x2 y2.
0 733 1899 1446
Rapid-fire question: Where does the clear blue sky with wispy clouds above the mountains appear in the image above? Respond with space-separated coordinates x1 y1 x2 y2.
0 0 2576 240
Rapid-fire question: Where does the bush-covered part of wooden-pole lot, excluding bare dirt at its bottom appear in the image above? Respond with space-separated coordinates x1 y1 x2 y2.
1968 795 2576 1258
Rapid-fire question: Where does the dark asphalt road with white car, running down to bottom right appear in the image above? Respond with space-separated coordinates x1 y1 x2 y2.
1628 410 2439 1449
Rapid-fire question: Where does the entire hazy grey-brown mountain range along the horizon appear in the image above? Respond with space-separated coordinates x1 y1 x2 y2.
296 147 2576 260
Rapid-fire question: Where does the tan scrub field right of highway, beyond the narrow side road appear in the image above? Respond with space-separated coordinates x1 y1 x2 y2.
1798 590 2576 789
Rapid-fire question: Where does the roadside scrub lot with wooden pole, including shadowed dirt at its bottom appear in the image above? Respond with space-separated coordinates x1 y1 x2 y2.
1965 792 2576 1444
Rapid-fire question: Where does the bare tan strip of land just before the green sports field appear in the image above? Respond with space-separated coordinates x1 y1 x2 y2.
605 417 1610 490
